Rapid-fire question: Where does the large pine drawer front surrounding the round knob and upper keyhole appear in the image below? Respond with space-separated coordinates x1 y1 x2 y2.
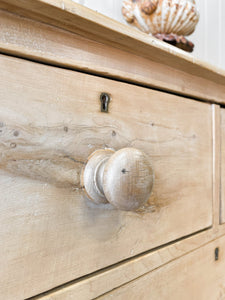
0 56 212 299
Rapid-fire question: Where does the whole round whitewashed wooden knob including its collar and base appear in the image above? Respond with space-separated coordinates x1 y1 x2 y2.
82 148 154 211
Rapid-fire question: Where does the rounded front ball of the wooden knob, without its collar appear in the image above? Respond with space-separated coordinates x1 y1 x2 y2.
102 148 154 211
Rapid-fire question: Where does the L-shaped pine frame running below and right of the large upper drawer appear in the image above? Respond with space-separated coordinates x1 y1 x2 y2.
27 105 225 300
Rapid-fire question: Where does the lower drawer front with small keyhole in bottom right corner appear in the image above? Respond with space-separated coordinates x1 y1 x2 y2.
98 237 225 300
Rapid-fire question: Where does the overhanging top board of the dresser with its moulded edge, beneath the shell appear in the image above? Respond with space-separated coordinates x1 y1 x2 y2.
0 0 225 84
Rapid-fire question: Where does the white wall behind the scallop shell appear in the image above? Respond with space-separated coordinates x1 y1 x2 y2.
73 0 225 69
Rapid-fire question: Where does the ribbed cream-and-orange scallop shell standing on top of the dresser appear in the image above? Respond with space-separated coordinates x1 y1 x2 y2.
122 0 199 36
